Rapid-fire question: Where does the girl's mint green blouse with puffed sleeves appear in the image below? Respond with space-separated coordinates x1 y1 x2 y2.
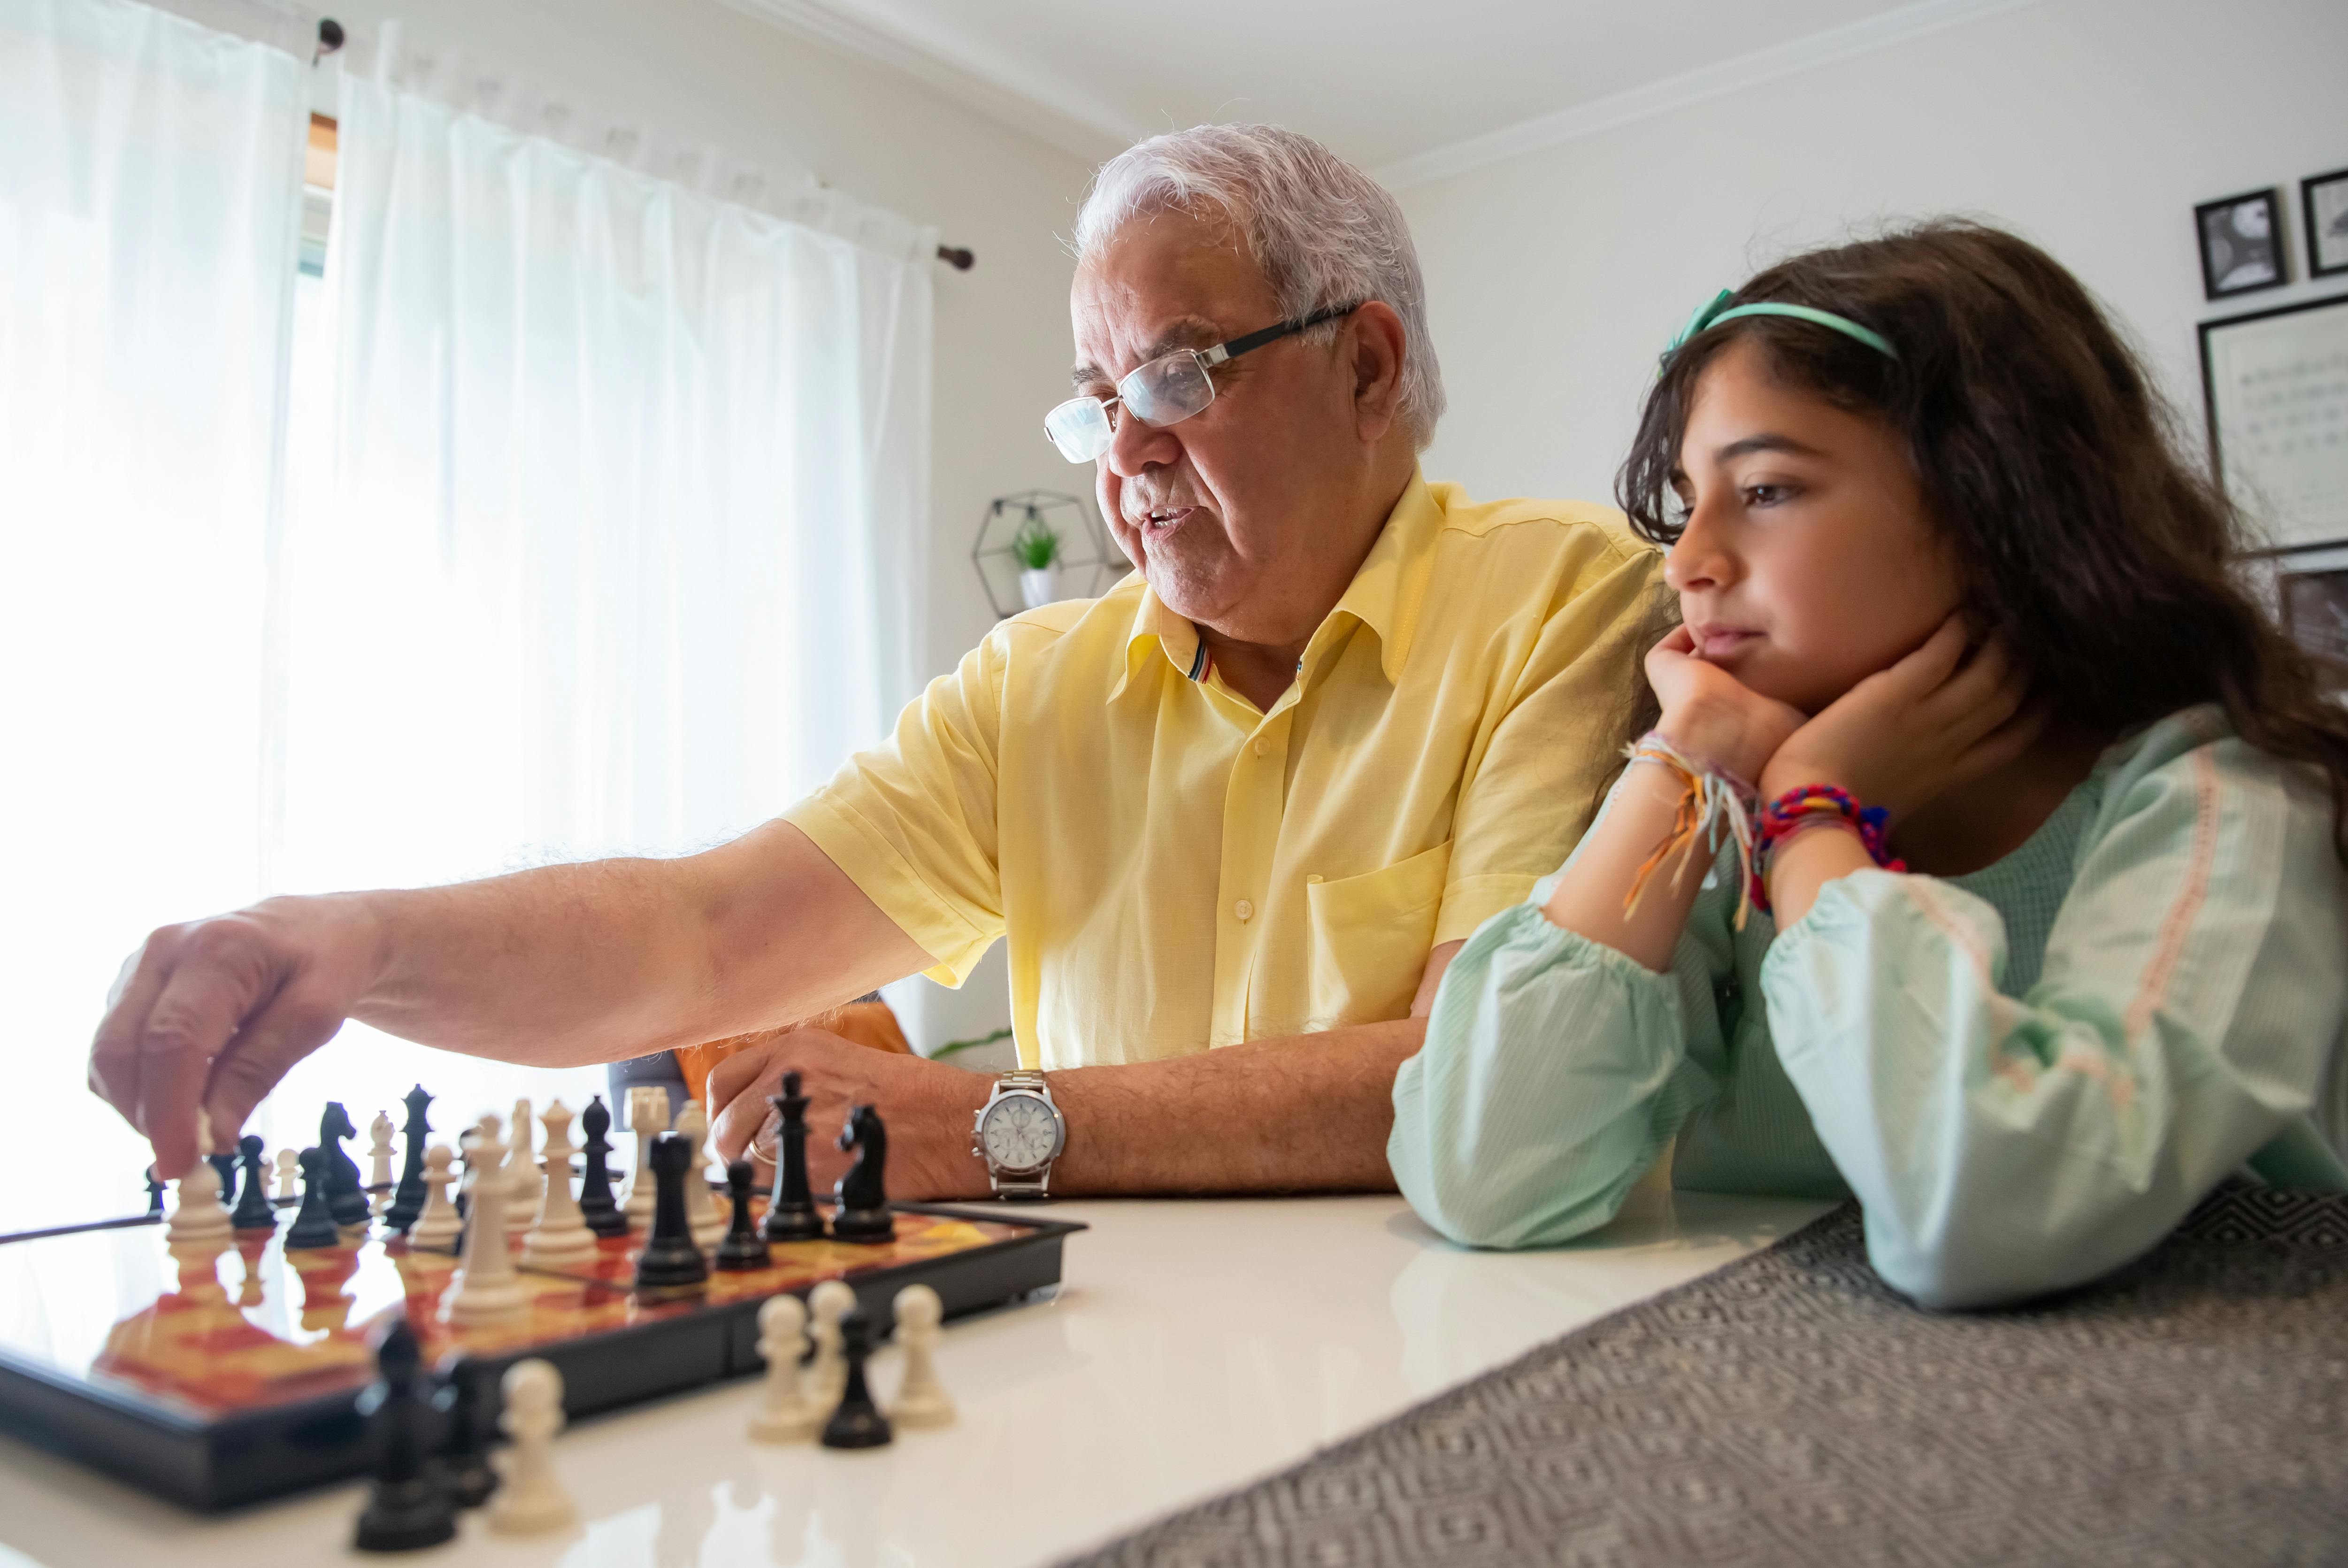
1388 709 2348 1307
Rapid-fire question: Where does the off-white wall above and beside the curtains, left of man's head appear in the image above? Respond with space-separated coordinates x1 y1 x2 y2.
305 0 1092 1061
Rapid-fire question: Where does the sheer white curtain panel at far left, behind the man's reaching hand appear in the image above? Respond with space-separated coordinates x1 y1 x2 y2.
0 0 310 1230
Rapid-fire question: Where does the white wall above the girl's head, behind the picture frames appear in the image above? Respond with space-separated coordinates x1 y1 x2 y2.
1399 0 2348 514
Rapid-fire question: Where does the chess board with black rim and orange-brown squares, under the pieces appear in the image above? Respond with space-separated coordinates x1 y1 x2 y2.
0 1199 1082 1509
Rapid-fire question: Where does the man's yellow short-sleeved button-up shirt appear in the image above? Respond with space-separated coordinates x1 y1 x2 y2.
787 474 1662 1068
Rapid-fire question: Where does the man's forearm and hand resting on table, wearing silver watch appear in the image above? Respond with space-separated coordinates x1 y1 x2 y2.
709 941 1460 1197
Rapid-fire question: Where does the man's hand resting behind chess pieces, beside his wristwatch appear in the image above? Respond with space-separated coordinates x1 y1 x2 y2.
709 1028 993 1199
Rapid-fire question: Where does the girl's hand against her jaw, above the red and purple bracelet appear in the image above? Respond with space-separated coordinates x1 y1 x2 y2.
1761 615 2045 822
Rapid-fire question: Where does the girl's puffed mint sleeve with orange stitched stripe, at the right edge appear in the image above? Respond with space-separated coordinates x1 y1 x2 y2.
1761 737 2348 1307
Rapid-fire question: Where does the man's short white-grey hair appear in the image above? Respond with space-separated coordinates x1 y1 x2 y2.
1075 124 1444 451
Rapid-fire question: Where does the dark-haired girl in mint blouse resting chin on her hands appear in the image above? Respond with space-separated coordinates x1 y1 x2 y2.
1388 223 2348 1307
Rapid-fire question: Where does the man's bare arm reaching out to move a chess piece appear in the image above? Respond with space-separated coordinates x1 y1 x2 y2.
89 822 930 1176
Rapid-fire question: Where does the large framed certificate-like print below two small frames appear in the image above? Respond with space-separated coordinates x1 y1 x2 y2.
2200 293 2348 547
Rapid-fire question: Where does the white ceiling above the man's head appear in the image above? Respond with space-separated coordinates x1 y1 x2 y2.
728 0 2022 185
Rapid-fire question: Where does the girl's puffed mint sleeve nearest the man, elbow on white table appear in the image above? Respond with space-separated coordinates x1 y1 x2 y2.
1385 807 1735 1246
